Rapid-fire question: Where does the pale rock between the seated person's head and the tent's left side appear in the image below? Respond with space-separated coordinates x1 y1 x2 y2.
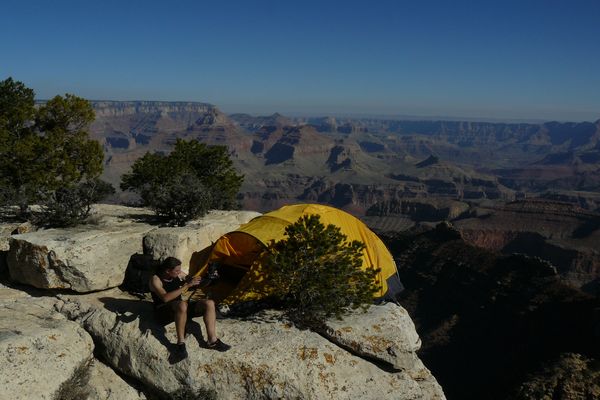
144 211 261 271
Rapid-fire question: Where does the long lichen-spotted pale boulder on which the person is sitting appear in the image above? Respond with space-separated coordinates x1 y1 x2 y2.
60 289 445 399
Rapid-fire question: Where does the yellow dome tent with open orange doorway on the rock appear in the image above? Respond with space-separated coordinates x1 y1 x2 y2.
190 204 402 303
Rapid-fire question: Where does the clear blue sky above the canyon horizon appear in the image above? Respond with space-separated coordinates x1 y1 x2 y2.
0 0 600 121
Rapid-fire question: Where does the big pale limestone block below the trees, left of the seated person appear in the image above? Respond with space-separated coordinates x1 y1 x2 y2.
7 205 154 292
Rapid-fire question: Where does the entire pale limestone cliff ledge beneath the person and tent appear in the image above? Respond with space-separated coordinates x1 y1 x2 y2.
0 206 445 399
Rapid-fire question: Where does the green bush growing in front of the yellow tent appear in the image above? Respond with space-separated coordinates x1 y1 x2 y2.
263 215 380 326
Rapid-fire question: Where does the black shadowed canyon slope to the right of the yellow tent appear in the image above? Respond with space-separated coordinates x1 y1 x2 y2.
383 223 600 400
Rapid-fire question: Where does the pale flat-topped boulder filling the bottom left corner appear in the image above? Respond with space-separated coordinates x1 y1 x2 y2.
0 287 94 400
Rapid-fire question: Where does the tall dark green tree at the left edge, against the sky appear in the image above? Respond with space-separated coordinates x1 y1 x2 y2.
0 78 106 223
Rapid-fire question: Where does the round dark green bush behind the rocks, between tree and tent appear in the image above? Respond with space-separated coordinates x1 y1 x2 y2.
121 139 244 225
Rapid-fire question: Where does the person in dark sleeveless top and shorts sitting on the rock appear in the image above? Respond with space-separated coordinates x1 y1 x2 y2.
150 257 231 358
